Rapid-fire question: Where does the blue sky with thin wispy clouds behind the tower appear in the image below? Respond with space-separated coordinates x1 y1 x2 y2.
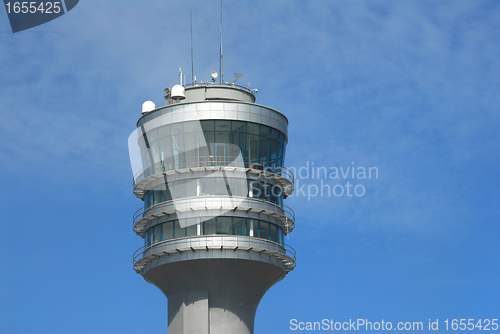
0 0 500 334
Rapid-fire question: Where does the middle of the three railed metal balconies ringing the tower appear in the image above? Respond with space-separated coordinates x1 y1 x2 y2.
133 195 295 234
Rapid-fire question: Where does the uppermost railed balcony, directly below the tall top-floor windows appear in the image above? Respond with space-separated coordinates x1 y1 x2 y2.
133 155 294 190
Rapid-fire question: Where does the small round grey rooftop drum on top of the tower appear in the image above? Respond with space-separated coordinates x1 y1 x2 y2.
163 81 257 106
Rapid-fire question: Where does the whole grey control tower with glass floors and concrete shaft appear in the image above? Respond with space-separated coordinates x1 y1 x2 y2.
129 72 295 334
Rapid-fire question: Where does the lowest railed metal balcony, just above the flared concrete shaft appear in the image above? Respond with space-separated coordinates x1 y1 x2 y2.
132 234 296 272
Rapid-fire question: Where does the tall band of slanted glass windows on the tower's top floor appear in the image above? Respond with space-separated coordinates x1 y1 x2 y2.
139 120 286 177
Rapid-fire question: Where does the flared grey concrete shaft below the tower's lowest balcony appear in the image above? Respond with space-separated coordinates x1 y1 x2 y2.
144 258 285 334
